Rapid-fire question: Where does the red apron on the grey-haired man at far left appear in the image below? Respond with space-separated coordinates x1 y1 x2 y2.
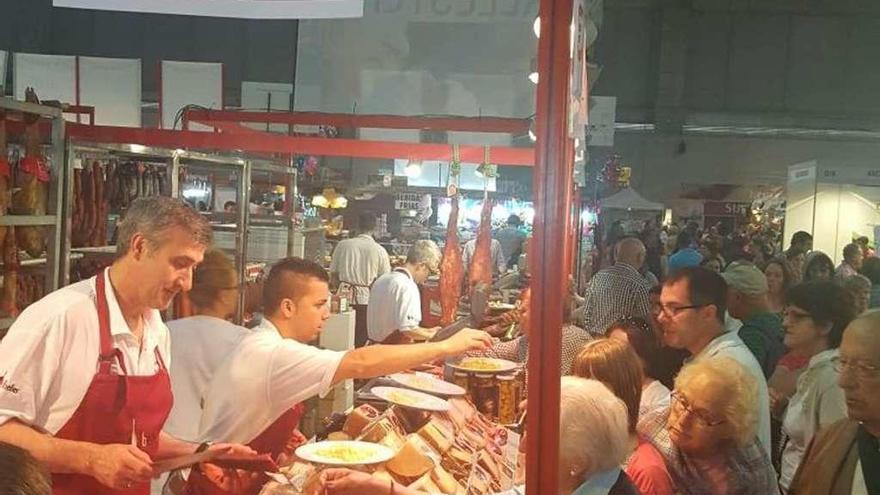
52 270 173 495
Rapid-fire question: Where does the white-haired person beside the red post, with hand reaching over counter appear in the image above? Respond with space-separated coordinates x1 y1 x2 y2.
321 376 639 495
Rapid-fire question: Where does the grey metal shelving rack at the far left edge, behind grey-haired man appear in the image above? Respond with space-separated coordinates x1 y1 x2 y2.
0 97 67 331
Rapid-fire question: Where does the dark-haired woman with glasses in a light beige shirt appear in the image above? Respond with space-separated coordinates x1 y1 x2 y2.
770 281 855 492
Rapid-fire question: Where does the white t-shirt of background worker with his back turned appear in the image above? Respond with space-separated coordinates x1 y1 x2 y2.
330 234 391 304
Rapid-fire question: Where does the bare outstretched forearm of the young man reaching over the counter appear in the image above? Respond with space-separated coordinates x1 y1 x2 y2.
333 342 451 383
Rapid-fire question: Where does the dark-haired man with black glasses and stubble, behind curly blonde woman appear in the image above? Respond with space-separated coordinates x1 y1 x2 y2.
657 267 771 457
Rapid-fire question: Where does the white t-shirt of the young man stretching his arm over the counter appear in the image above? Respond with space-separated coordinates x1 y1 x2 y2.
199 319 345 443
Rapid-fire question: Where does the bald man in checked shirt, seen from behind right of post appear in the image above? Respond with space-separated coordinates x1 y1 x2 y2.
578 237 651 336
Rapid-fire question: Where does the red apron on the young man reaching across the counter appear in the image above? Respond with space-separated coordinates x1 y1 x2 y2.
185 404 305 495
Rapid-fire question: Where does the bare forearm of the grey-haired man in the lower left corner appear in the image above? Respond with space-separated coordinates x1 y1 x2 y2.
0 419 95 474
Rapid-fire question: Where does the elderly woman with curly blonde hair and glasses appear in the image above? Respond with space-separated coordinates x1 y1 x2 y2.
639 357 779 495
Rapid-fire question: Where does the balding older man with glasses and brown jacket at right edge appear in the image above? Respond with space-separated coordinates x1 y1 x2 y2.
790 311 880 495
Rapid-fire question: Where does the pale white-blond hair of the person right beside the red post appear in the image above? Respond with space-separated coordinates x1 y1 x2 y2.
559 376 629 478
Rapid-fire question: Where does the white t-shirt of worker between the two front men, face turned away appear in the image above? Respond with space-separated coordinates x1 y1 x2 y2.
163 316 253 442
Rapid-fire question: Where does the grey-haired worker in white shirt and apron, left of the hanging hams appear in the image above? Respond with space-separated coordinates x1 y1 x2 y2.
367 240 442 344
